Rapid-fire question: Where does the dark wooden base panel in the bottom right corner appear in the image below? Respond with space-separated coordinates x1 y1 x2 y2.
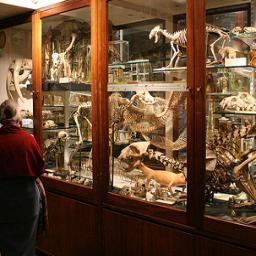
196 237 256 256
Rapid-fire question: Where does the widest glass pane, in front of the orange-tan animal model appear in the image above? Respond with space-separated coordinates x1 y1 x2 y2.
108 0 187 210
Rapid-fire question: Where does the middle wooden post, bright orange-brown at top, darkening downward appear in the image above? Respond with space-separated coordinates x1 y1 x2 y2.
91 0 108 198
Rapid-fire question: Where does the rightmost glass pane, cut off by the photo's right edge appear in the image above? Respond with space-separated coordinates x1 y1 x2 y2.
205 1 256 224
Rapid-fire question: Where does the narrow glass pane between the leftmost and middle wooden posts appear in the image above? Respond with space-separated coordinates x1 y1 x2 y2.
42 8 92 187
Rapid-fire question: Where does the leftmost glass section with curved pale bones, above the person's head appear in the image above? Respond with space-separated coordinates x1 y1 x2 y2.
0 23 33 134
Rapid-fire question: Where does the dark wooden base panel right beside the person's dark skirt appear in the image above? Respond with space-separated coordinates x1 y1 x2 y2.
38 192 99 256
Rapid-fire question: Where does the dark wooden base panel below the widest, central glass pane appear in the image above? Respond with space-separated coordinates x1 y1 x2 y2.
103 210 194 256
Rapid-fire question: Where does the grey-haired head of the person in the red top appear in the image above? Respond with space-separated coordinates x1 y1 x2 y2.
0 100 21 125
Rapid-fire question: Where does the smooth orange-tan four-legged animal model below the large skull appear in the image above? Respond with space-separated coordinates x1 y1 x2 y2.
133 160 186 192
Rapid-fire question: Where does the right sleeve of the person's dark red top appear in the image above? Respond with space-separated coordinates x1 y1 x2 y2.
28 135 44 177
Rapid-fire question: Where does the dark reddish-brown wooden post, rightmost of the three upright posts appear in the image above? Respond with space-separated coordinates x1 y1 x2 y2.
187 0 206 229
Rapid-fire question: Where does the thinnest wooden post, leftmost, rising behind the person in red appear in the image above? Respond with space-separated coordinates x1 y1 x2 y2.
32 11 43 146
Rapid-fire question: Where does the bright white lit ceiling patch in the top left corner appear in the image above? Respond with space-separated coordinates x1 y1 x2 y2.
0 0 66 10
